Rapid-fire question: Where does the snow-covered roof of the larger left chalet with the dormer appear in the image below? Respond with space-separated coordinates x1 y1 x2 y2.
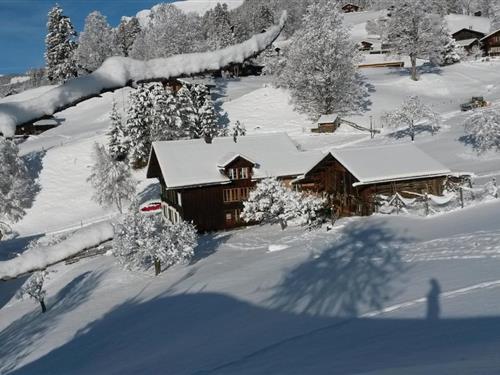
148 133 325 189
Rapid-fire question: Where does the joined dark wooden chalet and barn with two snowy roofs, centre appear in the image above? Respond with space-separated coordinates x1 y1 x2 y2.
147 134 451 232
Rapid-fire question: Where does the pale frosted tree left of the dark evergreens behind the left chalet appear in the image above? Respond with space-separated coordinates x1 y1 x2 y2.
87 143 137 212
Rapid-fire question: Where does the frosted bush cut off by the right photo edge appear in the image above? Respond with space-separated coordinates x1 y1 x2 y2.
464 108 500 153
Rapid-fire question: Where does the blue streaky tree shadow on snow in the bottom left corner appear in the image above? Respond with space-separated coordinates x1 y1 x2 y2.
0 272 102 373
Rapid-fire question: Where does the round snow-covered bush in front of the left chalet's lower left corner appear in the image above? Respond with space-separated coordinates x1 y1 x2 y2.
113 205 197 275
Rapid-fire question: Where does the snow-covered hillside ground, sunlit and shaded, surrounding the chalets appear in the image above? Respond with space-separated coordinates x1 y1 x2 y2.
0 8 500 374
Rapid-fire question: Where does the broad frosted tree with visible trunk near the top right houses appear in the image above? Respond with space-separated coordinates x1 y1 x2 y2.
384 0 444 81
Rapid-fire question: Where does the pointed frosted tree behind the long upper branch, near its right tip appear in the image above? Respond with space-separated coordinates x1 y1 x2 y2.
207 3 236 51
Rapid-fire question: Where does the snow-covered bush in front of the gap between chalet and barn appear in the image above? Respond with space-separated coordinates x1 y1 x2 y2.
241 177 326 229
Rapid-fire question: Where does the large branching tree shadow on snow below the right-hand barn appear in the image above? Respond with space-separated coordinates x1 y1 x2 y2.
268 222 405 317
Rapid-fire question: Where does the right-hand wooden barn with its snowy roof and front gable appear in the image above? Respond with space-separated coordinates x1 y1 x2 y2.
293 143 451 216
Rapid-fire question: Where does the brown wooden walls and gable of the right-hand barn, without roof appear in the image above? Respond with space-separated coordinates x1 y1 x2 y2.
296 154 446 216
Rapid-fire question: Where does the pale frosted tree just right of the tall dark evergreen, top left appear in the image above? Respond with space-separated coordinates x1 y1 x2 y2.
75 11 119 73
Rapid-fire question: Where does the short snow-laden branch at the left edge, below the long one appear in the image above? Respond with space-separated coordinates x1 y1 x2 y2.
0 222 114 280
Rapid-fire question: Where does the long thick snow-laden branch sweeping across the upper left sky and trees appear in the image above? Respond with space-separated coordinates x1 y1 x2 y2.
0 12 286 137
